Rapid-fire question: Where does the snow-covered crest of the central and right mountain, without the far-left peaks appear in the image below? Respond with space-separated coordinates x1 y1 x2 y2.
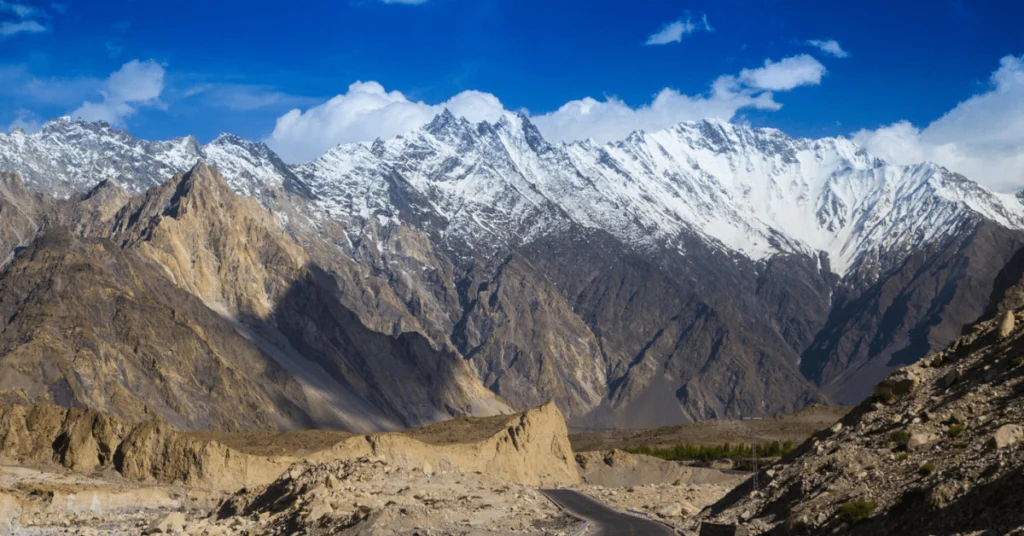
298 114 1024 275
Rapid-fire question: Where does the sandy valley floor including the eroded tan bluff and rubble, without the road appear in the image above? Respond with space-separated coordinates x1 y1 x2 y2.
0 395 839 536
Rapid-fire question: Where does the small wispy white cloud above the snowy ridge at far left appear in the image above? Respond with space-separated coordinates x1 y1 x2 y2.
71 59 164 125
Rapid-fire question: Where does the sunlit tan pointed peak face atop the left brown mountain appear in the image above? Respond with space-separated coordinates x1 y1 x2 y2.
111 163 308 318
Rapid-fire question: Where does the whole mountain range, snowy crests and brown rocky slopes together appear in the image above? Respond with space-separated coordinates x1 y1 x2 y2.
0 112 1024 430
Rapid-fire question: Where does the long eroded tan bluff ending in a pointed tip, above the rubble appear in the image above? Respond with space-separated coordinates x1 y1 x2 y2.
0 404 580 491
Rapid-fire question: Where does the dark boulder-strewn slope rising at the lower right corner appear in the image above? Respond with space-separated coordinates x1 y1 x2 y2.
710 262 1024 534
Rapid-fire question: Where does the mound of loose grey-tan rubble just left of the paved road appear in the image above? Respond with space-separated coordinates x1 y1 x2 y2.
185 458 578 536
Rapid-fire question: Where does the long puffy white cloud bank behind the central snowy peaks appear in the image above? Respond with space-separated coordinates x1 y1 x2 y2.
266 56 824 162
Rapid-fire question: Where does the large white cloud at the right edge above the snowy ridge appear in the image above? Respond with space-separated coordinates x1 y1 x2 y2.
853 55 1024 192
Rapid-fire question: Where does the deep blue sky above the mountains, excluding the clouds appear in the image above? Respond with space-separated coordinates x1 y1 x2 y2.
0 0 1024 141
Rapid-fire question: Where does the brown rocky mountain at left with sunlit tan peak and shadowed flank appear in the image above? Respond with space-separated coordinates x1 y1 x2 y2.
0 164 509 431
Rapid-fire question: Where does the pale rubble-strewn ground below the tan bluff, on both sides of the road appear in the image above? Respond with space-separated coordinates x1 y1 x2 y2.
0 455 743 536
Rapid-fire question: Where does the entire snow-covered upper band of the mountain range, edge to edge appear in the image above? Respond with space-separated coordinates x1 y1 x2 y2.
0 115 1024 275
